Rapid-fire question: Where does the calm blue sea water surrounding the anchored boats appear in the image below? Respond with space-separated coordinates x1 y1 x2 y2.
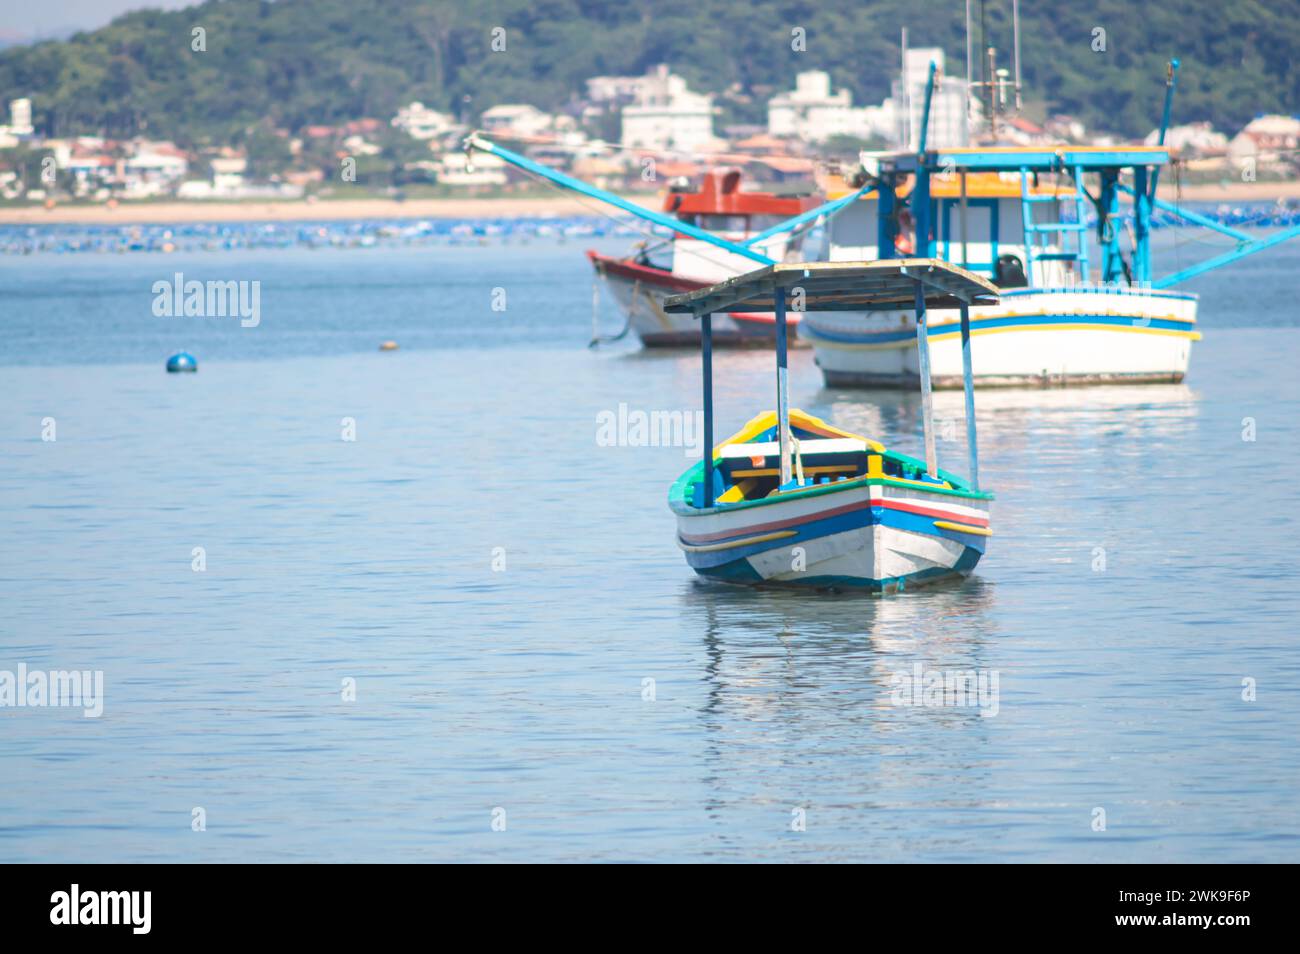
0 233 1300 862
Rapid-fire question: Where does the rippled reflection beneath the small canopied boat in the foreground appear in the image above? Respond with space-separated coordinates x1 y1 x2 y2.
677 576 998 860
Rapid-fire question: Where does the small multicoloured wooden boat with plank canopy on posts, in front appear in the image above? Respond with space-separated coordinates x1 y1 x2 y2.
664 259 997 593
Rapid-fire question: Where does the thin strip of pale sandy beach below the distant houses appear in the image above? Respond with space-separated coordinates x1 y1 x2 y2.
0 181 1300 225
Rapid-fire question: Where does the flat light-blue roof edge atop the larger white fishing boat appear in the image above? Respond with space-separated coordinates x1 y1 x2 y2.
879 144 1170 173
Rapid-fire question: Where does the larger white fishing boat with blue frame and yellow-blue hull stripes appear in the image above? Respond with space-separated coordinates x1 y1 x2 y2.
803 146 1201 387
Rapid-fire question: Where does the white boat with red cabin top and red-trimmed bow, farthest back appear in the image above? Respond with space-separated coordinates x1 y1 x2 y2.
586 168 824 347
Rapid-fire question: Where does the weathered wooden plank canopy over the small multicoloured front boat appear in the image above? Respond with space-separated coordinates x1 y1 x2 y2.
663 259 998 315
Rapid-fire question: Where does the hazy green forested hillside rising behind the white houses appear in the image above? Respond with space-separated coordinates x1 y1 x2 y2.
0 0 1300 146
